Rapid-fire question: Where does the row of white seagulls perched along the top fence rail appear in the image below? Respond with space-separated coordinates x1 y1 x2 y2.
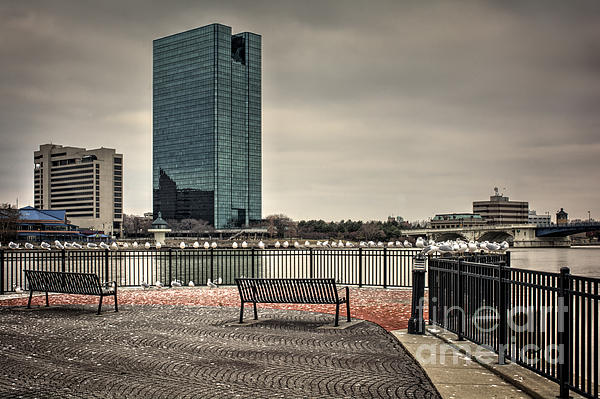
0 237 509 254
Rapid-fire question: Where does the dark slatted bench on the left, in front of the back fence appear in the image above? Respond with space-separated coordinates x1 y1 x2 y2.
25 270 119 314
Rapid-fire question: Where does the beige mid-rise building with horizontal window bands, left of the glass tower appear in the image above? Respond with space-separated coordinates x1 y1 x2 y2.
33 144 123 235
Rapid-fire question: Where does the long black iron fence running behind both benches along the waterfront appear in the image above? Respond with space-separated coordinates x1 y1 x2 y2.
0 248 419 294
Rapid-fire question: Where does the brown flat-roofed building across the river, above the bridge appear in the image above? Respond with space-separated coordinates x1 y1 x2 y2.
473 187 529 224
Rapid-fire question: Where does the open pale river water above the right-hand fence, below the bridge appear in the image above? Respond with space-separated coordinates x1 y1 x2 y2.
510 246 600 278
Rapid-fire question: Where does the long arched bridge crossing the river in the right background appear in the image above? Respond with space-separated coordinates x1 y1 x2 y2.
402 222 600 247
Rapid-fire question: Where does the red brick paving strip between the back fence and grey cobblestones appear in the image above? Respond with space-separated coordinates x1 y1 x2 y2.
0 287 427 331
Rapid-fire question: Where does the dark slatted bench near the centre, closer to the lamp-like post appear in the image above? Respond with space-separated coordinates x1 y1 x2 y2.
235 278 350 327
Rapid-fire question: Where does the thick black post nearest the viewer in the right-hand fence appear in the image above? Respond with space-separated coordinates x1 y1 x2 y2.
558 267 571 399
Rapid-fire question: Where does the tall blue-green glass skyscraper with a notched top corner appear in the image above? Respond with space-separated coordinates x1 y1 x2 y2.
152 24 262 228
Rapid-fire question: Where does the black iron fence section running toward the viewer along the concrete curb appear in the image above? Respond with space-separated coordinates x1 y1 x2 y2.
428 257 600 398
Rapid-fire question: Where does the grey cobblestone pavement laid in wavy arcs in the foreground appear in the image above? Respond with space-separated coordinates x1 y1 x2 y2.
0 305 440 398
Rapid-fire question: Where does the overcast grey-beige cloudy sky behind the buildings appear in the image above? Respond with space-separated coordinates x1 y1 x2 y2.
0 0 600 220
